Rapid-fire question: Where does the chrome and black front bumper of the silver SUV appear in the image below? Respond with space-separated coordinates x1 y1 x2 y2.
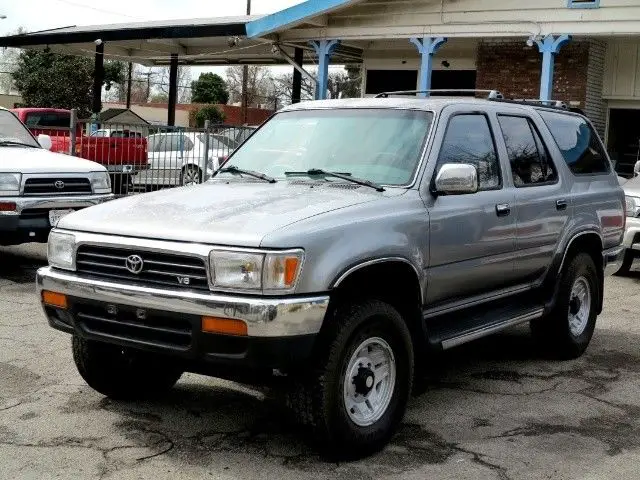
36 267 329 369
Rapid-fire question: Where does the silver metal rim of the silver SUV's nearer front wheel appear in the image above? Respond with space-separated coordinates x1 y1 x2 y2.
343 337 396 427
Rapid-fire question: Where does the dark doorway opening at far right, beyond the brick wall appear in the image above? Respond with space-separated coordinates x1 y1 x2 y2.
607 109 640 178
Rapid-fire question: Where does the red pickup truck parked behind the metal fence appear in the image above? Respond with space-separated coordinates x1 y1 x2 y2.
12 108 149 194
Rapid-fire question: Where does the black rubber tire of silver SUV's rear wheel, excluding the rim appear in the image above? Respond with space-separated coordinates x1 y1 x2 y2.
531 253 601 360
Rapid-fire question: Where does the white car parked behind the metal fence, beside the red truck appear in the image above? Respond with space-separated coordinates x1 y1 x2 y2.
133 132 235 186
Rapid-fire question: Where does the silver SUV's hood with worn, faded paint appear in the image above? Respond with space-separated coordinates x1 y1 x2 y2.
58 181 398 247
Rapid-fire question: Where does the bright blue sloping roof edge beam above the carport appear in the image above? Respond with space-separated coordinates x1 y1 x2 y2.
247 0 362 38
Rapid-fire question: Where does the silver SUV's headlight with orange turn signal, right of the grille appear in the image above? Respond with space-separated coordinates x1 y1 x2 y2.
209 250 304 293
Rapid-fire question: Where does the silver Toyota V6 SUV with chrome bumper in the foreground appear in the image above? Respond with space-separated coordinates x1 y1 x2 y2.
37 97 625 457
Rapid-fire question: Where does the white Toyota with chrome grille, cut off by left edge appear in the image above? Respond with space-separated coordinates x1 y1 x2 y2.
0 108 113 245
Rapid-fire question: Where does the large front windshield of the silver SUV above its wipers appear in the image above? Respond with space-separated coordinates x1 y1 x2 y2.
220 109 433 185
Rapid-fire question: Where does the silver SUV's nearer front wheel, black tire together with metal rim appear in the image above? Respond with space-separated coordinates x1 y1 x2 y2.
290 300 414 459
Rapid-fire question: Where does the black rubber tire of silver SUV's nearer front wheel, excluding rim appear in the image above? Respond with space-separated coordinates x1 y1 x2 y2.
287 300 414 460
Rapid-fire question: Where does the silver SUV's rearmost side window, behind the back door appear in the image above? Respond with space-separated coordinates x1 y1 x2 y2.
539 111 610 175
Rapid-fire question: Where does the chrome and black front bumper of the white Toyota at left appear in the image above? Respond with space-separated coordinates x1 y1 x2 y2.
0 194 114 244
